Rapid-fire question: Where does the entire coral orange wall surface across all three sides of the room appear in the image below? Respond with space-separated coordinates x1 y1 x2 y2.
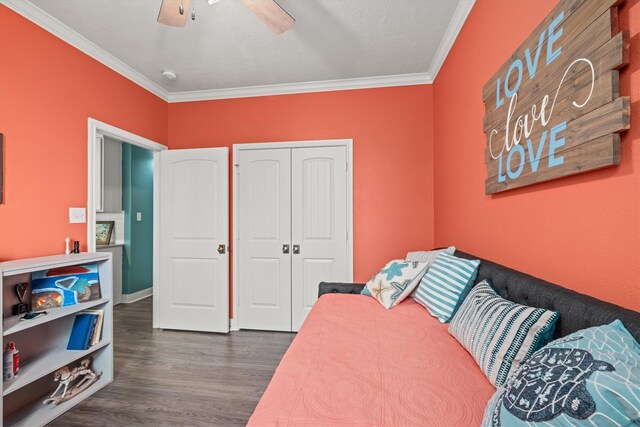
6 0 640 318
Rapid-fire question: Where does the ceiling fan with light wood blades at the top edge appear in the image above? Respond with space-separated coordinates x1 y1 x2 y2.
158 0 296 35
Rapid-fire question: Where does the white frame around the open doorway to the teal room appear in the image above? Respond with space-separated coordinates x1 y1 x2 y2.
87 117 169 328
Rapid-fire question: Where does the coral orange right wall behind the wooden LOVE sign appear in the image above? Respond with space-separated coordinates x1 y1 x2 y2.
434 0 640 310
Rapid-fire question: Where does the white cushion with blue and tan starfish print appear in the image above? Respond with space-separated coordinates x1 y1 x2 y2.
361 259 427 308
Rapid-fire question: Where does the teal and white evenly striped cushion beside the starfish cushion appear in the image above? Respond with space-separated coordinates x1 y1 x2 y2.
413 251 480 323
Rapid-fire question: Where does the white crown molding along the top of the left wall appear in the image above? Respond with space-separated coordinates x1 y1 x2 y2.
0 0 169 101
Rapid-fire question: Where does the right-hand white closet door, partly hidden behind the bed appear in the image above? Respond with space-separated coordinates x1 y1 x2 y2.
291 147 347 331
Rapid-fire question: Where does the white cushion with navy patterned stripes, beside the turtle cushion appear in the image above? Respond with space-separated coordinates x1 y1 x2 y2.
449 280 560 387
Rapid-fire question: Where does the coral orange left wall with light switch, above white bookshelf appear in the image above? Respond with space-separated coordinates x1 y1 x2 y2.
0 5 167 260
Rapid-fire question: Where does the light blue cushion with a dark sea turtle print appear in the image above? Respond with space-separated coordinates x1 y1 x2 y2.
482 320 640 426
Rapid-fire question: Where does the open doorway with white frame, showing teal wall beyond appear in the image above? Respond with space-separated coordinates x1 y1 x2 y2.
87 119 167 327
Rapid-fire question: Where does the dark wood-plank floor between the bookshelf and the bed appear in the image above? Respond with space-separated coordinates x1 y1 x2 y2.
50 298 295 426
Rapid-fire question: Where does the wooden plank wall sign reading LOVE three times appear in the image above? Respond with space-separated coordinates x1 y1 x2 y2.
482 0 630 194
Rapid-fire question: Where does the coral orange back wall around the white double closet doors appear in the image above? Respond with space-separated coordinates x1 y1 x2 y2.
169 85 433 281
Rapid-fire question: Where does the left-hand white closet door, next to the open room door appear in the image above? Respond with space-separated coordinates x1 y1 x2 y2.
238 149 291 331
